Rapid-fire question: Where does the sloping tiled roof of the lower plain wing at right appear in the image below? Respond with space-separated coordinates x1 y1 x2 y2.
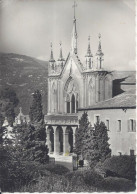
79 93 136 110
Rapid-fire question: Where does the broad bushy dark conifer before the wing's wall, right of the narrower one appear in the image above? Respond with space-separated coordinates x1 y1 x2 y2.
84 122 111 166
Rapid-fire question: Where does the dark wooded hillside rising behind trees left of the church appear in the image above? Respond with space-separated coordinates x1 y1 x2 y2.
0 53 48 114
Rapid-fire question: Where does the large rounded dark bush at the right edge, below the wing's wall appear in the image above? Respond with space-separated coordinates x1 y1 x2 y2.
95 155 136 182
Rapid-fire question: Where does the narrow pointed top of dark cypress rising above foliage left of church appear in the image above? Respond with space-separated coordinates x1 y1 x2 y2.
29 90 43 122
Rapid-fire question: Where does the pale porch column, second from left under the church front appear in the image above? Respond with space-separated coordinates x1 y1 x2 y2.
53 126 60 155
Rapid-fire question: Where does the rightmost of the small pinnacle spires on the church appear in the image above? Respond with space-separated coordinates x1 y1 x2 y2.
96 34 104 69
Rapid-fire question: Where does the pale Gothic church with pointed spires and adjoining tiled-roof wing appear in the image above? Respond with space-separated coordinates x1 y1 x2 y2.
45 7 136 158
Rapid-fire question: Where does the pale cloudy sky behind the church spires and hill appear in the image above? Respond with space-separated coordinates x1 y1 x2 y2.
0 0 135 70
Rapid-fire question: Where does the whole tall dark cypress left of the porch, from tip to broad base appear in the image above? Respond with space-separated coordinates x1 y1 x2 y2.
23 90 49 163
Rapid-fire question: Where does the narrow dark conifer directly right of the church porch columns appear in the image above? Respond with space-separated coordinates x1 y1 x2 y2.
75 112 89 156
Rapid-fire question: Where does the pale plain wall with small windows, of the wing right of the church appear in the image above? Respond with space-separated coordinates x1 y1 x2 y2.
78 109 136 155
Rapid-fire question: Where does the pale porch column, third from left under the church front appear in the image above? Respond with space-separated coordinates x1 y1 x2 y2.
62 127 70 156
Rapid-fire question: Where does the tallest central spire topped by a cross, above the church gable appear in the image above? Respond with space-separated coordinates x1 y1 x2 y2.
71 1 77 54
